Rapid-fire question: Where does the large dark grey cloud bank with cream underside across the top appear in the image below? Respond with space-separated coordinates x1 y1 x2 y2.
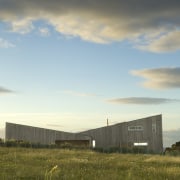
0 0 180 52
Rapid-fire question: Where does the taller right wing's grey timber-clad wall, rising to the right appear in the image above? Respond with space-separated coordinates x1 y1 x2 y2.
81 115 163 153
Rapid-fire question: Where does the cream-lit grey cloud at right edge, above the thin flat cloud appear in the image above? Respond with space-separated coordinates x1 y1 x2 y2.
131 67 180 89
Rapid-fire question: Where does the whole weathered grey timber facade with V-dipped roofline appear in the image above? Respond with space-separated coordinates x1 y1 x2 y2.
5 115 163 153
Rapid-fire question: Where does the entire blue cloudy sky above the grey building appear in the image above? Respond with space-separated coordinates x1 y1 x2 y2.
0 0 180 145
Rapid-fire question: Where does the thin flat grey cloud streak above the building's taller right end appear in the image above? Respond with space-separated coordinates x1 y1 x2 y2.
107 97 180 105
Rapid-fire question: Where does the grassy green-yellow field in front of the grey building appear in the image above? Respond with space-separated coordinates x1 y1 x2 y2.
0 147 180 180
